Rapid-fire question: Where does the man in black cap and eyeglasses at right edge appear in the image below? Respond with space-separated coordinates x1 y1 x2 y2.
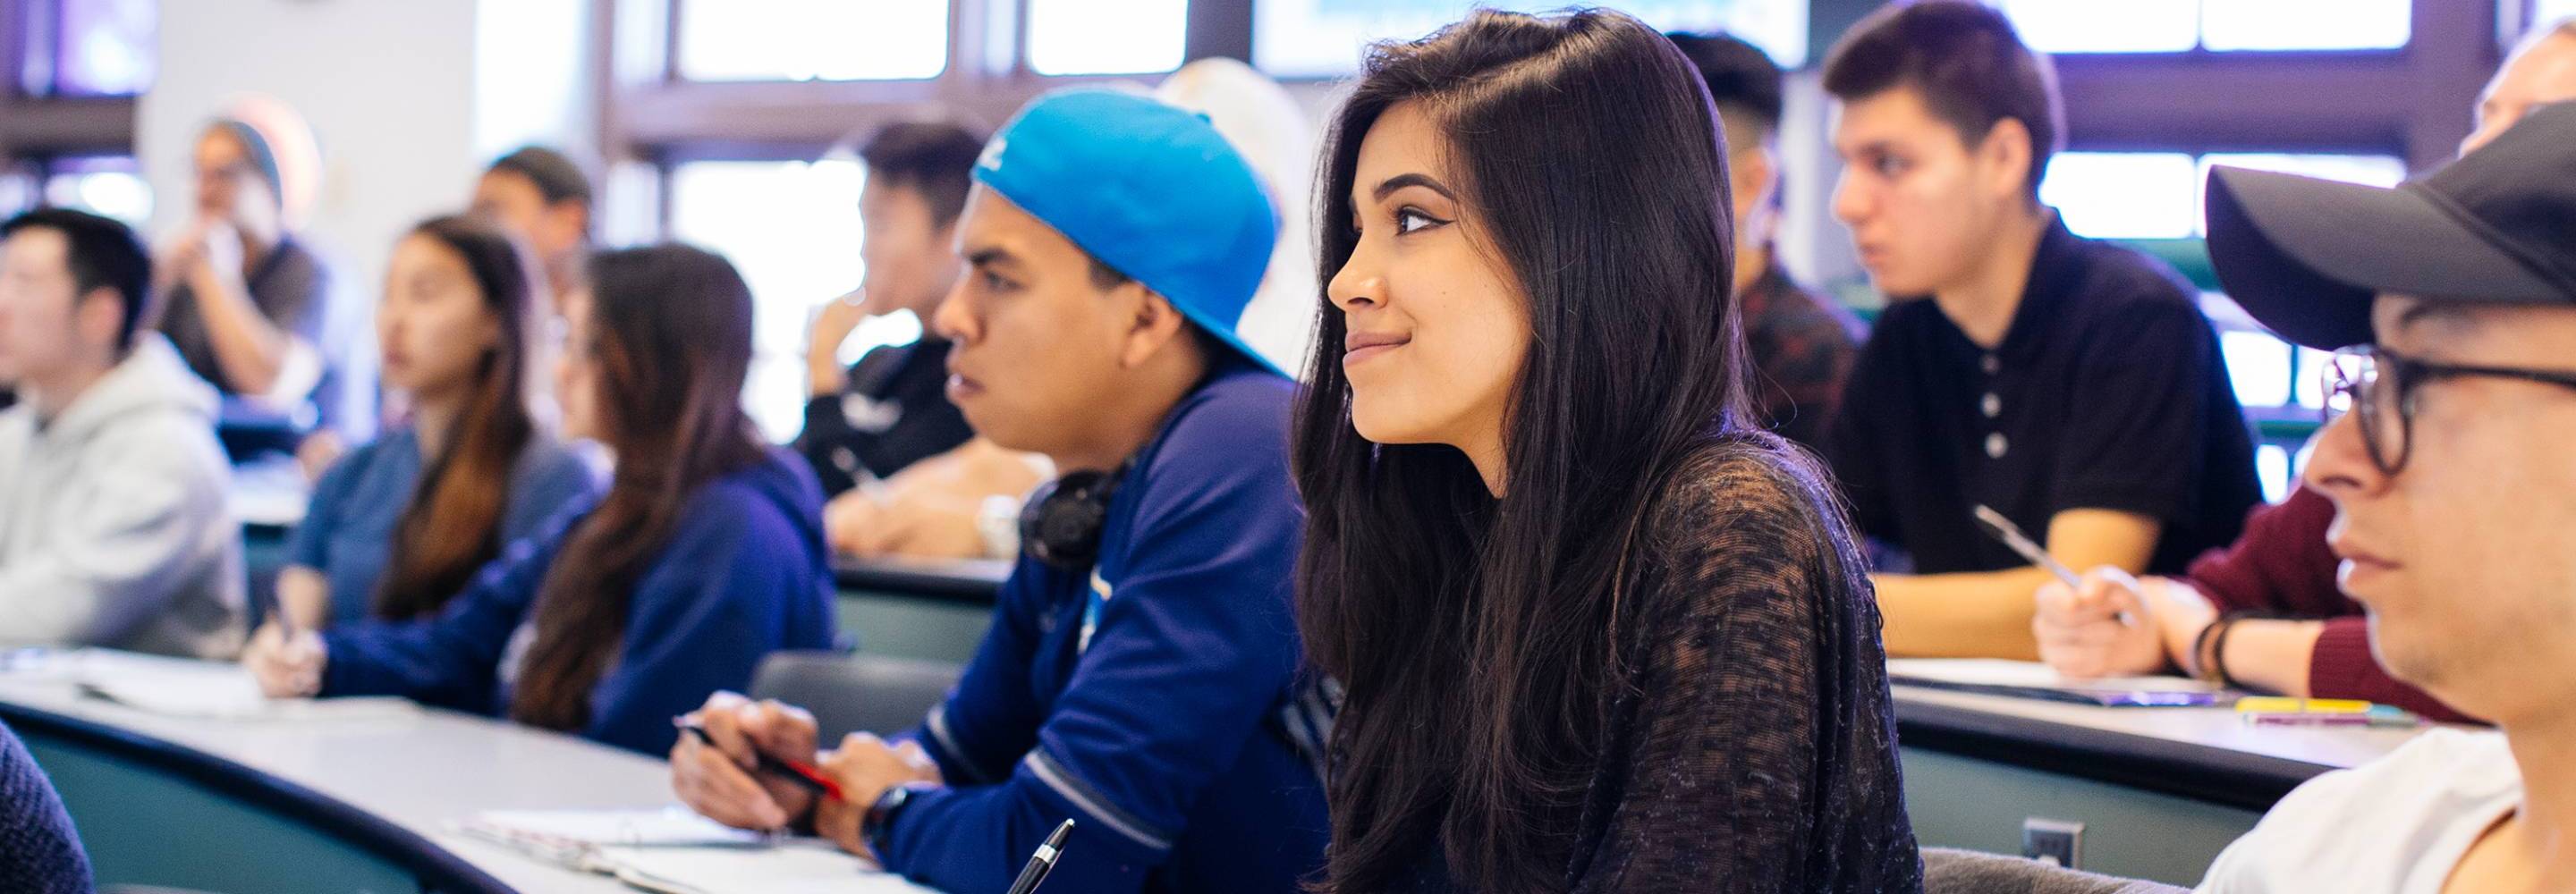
2202 105 2576 894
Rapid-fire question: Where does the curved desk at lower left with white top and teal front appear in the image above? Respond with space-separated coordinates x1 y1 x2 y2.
0 675 917 894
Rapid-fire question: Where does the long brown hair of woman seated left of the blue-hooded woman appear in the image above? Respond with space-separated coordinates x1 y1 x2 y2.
374 214 538 621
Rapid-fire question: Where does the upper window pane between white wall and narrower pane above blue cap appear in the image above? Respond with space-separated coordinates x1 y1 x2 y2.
675 0 948 80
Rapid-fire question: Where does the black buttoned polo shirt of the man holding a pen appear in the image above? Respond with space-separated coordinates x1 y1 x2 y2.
1826 224 2262 575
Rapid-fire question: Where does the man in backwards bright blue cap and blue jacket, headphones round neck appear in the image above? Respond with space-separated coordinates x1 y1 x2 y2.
673 90 1326 891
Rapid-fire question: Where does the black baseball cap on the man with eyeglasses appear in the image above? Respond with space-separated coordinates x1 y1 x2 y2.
2207 103 2576 350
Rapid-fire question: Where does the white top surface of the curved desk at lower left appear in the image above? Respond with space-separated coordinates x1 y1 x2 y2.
0 659 927 894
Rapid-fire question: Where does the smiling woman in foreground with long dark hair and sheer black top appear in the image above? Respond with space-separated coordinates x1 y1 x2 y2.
1293 11 1921 891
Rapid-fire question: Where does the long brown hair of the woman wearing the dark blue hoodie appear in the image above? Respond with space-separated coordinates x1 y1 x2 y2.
510 245 767 730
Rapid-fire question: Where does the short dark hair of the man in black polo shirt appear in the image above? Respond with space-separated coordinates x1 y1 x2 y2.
1824 0 2066 198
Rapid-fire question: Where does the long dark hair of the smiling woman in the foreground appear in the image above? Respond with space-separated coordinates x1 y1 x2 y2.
1291 11 1744 891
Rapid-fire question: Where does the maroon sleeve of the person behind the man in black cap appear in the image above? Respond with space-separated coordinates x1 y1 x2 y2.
2190 487 2476 721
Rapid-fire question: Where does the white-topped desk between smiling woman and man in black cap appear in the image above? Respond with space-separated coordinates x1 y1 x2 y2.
1894 686 2421 886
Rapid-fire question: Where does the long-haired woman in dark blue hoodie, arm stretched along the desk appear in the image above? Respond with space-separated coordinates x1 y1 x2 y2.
245 245 832 755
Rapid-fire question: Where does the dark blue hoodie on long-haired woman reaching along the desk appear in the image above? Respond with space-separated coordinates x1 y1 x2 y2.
322 451 832 755
